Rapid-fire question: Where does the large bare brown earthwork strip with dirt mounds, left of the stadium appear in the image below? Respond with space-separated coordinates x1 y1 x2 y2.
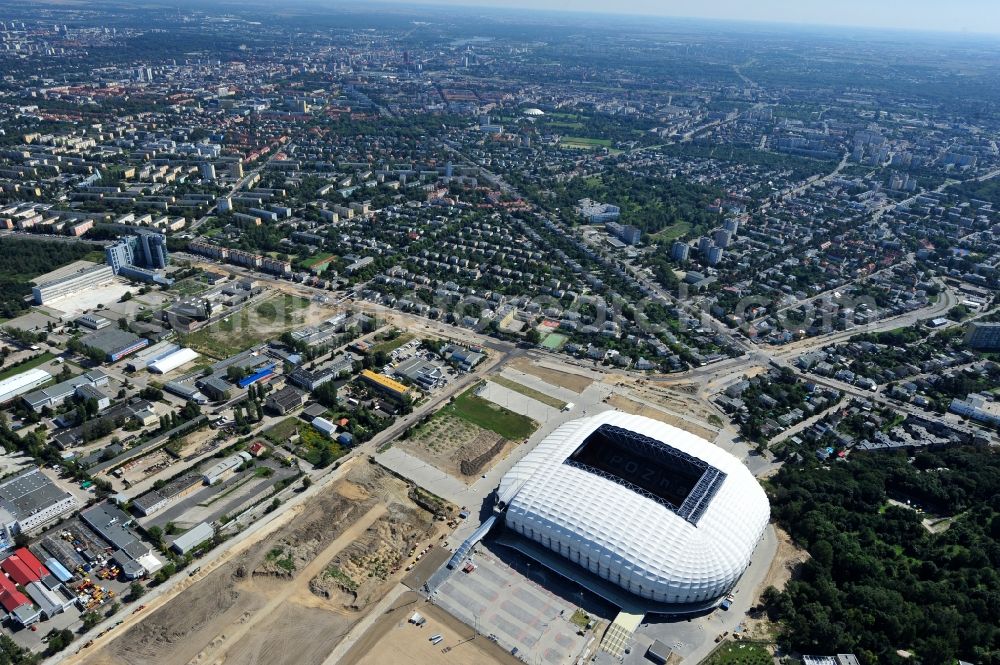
76 458 454 665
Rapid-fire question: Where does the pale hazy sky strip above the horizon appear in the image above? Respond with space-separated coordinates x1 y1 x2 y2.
380 0 1000 34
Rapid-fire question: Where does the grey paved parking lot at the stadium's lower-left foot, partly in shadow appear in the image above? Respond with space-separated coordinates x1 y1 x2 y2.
433 546 600 665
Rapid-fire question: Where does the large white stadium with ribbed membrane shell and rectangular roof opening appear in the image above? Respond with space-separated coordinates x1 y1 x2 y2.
497 411 770 608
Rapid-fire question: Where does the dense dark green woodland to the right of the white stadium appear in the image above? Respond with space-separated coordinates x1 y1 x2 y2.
764 448 1000 665
